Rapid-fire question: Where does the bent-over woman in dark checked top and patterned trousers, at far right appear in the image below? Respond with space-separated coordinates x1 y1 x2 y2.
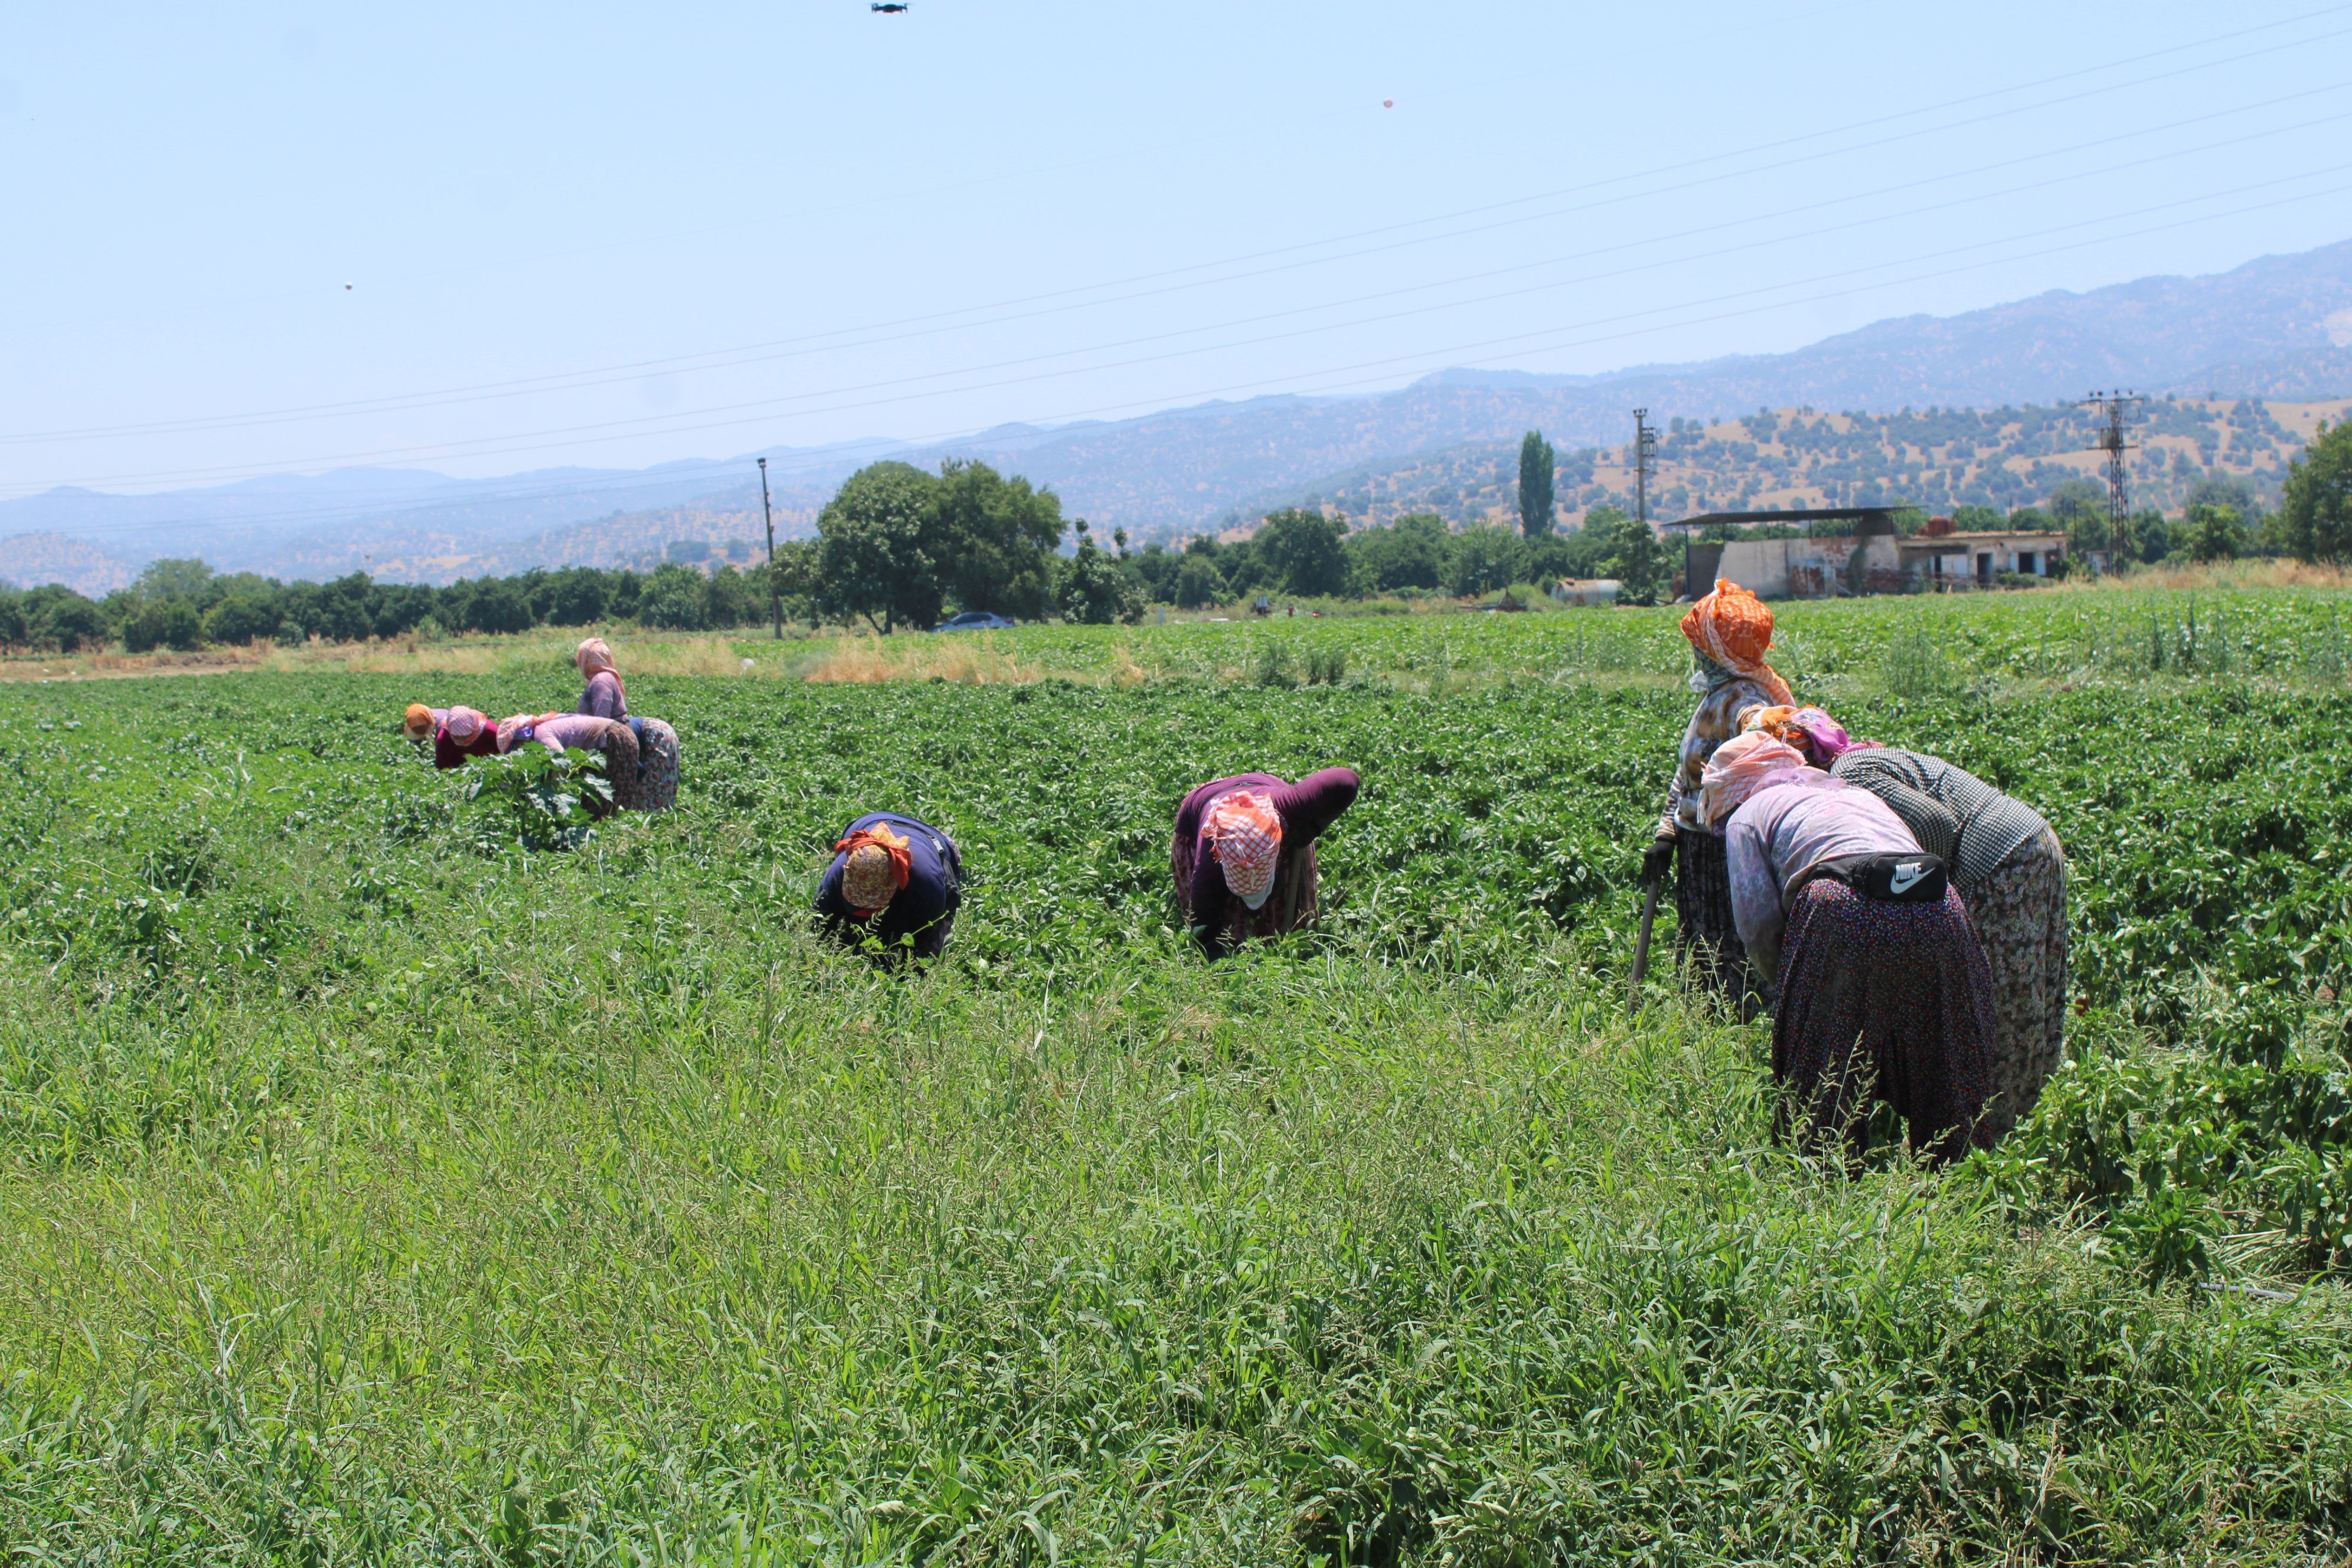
1740 708 2067 1142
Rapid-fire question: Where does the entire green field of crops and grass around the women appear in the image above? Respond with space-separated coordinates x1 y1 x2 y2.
0 590 2352 1566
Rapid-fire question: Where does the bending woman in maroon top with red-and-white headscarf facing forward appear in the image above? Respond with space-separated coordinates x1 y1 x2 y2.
1169 769 1364 959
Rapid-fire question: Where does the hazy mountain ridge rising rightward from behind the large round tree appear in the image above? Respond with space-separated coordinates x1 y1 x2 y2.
925 242 2352 531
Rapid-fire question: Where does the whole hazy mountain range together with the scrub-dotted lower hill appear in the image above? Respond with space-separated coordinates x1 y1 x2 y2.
0 242 2352 590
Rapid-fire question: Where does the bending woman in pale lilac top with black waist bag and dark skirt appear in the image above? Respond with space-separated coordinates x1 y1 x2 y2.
1698 733 1992 1159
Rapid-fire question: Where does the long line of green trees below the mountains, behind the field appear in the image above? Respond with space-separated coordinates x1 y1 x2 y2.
14 421 2352 654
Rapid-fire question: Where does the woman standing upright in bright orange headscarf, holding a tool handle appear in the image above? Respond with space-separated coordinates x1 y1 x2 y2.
1642 579 1795 987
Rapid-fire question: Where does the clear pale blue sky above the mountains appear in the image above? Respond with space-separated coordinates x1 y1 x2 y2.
0 0 2352 496
